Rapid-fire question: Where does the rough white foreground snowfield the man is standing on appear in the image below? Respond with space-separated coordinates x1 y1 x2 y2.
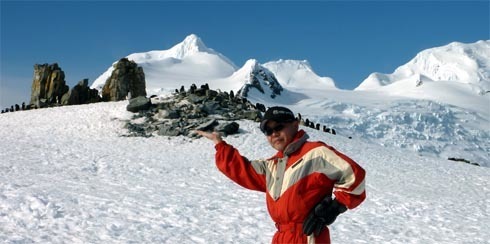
0 101 490 244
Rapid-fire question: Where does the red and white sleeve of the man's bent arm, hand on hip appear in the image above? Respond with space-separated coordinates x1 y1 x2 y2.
327 146 366 209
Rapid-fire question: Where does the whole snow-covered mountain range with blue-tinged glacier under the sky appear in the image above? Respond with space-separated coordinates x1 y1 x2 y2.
92 35 490 166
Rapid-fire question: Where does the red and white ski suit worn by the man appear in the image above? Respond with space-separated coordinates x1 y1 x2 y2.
215 130 366 243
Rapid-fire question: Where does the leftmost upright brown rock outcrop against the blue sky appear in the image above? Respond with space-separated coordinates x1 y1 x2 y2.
30 63 69 108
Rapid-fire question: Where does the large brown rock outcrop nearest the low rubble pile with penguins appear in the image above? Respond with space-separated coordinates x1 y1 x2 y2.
102 58 146 101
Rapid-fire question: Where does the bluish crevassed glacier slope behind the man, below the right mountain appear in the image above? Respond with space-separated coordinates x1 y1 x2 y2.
229 82 490 167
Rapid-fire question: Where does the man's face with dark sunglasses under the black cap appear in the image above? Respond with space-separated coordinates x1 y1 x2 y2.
265 120 299 151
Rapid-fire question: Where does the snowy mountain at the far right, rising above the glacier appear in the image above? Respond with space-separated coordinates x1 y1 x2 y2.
355 40 490 95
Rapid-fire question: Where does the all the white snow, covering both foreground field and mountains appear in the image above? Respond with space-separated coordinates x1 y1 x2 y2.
0 35 490 243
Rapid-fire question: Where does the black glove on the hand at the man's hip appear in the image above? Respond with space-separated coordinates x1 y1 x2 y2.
303 197 347 236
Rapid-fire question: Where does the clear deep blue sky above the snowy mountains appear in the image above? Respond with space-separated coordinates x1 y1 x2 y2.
0 0 490 108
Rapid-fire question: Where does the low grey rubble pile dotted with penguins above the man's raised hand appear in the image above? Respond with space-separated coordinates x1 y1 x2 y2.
124 84 265 137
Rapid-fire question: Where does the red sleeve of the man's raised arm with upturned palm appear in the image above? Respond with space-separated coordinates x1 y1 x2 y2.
215 141 266 192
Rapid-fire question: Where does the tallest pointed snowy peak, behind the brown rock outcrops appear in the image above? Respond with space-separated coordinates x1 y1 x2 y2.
91 35 237 94
